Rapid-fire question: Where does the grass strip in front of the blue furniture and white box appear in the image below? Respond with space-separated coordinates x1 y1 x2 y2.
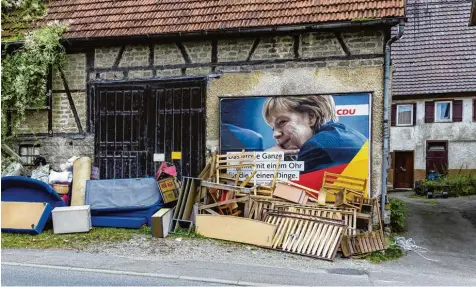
2 226 150 249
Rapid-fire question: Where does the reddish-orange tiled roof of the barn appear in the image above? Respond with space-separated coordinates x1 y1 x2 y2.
4 0 404 38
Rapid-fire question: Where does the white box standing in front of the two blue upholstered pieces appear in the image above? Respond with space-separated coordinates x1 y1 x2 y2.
51 205 91 234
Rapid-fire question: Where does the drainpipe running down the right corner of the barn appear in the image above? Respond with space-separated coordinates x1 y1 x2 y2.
380 21 405 217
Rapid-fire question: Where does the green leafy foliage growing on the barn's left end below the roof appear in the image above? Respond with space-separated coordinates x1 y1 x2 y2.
2 21 66 141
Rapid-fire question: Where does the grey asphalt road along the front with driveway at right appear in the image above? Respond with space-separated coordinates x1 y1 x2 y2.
1 193 476 286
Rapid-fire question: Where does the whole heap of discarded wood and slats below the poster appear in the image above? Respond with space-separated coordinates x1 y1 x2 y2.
193 151 383 260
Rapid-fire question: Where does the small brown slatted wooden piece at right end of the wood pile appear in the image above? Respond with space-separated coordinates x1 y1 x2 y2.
341 230 387 257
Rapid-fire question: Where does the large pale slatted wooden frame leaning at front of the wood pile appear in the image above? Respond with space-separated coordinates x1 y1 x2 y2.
266 212 347 261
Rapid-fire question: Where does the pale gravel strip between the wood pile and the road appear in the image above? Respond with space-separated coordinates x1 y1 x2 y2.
82 235 370 271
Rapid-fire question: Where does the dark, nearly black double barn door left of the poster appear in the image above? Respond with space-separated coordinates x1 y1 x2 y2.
90 81 205 179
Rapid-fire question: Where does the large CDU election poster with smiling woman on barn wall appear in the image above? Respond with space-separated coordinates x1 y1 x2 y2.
220 93 371 197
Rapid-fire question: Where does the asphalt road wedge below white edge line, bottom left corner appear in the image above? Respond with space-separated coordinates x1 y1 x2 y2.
2 264 223 286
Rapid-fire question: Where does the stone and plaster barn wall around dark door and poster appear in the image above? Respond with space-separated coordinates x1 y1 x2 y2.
14 30 384 194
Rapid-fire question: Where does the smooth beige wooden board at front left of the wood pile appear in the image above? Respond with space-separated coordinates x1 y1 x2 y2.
196 214 277 247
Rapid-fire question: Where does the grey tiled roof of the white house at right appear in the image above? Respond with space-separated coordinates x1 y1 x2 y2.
392 0 476 97
